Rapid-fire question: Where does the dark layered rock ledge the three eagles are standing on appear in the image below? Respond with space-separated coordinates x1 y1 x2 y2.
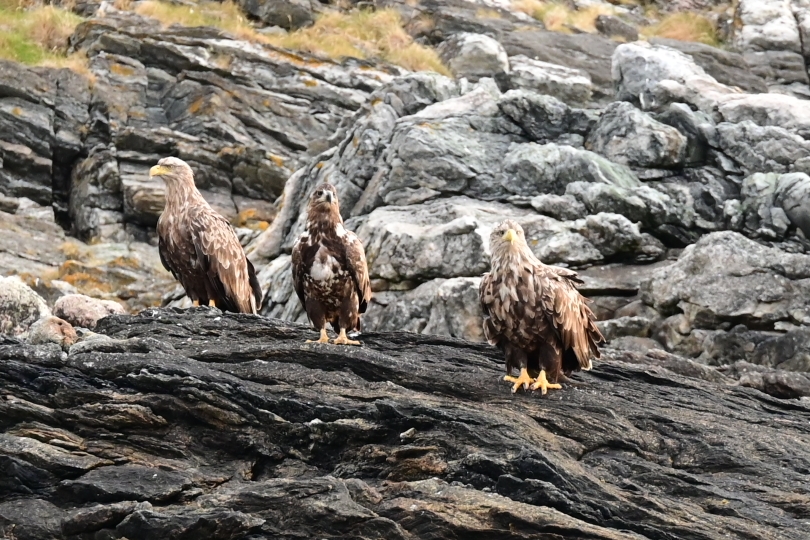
0 308 810 540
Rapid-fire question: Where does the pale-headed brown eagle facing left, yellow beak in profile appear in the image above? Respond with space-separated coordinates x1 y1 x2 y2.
149 157 262 313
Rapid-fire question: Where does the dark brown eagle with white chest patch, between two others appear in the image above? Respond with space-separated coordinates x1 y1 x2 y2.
292 184 371 345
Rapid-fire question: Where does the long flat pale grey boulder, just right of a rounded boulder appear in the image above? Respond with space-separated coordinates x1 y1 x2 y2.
507 54 593 105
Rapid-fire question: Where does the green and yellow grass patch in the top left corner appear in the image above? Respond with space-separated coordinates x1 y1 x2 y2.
0 0 82 65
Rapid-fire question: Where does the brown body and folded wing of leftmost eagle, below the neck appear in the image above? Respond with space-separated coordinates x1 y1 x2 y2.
158 205 262 313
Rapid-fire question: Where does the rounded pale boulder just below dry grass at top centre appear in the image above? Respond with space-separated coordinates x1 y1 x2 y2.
436 32 509 82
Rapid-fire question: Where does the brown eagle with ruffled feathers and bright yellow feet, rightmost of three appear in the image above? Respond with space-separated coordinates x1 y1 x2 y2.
479 220 604 394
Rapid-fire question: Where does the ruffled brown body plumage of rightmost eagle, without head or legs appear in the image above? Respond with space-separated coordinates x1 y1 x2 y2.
479 264 604 371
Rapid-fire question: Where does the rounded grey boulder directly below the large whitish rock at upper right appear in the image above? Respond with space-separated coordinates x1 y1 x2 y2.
587 102 687 168
